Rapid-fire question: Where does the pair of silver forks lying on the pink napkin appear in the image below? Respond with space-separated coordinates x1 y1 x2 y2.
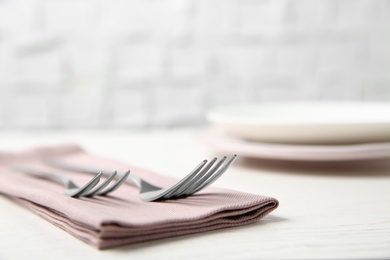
13 155 237 202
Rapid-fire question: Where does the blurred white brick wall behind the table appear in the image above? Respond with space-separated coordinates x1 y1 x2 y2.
0 0 390 129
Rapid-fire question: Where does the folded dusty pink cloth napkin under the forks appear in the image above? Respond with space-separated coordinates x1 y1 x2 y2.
0 145 278 249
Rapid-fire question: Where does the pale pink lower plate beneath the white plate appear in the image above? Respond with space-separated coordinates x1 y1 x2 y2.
200 131 390 161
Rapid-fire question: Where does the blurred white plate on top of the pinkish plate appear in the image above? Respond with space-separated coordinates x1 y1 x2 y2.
207 102 390 144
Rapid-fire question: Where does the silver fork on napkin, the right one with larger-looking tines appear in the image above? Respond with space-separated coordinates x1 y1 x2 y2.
45 155 237 201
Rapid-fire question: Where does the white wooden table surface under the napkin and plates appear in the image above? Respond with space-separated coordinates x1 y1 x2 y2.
0 129 390 260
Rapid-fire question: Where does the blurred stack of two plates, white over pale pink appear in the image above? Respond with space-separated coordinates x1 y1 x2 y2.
204 102 390 161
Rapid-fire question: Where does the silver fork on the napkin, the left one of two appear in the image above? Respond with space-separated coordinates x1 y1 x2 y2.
13 165 130 198
